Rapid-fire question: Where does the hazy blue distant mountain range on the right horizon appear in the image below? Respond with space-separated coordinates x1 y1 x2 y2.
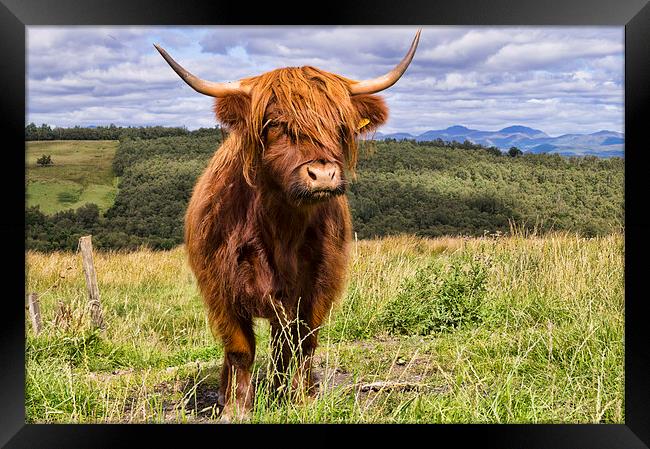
374 125 625 157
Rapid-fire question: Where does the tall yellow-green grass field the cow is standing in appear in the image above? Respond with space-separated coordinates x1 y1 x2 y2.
25 233 625 423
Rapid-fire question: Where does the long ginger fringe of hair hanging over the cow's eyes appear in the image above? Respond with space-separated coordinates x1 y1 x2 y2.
221 66 361 185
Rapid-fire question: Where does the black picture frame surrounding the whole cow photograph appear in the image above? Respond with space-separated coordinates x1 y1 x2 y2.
0 0 650 449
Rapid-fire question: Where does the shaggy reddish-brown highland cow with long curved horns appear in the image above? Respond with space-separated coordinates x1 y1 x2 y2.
156 30 420 416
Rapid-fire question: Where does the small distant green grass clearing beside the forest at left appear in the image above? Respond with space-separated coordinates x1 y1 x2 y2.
25 140 118 214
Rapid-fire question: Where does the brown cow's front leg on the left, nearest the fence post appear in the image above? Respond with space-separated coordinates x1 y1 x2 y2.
219 317 255 420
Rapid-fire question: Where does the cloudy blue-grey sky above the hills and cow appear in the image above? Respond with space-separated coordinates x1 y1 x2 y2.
26 26 624 136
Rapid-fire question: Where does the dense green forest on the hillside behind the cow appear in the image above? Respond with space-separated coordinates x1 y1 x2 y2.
26 128 624 251
